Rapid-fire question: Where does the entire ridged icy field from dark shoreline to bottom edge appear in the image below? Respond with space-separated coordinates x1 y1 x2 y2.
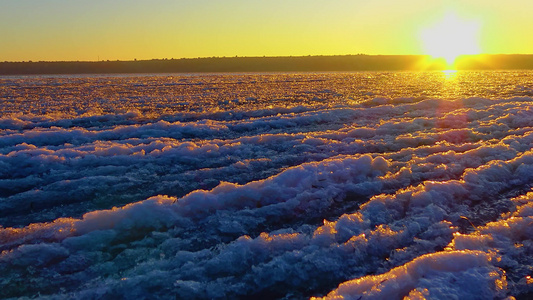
0 72 533 299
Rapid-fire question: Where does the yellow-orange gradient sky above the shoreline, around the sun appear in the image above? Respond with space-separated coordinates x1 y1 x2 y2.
0 0 533 61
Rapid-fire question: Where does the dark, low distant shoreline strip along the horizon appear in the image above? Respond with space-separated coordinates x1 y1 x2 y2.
0 54 533 75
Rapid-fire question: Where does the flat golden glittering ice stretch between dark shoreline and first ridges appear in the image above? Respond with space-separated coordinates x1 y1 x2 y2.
4 71 533 120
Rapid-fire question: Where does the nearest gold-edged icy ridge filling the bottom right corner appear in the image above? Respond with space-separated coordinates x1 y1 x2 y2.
324 193 533 299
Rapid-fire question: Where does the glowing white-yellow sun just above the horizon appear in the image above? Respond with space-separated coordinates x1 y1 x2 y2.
420 12 481 66
